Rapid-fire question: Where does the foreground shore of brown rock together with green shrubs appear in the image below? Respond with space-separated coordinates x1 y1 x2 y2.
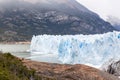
0 53 120 80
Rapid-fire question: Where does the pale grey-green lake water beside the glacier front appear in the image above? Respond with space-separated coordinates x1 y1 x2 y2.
0 44 61 63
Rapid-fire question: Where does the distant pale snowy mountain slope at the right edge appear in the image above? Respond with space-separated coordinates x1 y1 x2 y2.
107 16 120 31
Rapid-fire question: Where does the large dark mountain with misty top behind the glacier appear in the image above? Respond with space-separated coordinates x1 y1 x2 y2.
0 0 115 41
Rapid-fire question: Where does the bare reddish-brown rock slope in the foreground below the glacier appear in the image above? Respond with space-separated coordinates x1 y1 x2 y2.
22 59 120 80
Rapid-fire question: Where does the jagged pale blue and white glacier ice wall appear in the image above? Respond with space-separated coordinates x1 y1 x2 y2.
30 31 120 66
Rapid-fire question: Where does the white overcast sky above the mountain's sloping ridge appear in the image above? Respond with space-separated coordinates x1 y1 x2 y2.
77 0 120 19
